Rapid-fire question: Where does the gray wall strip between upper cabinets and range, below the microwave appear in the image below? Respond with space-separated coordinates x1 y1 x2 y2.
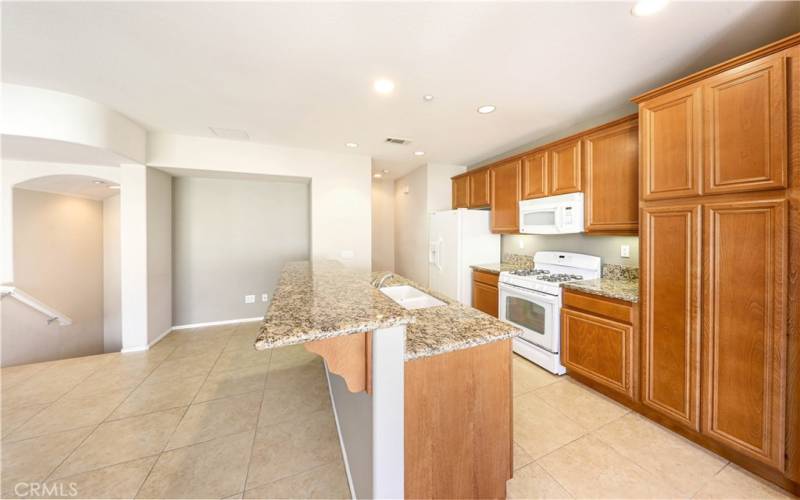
502 233 639 267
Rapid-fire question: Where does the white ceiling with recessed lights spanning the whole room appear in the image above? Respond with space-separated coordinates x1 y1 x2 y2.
2 2 800 177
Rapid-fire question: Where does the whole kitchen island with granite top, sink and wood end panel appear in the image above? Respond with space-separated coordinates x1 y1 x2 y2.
255 261 519 498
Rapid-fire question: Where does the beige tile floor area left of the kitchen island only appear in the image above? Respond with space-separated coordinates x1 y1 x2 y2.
0 324 350 498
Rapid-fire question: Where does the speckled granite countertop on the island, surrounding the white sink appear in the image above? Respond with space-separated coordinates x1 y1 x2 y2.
255 261 521 361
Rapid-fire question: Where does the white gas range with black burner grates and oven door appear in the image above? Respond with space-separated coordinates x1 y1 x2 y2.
499 252 601 375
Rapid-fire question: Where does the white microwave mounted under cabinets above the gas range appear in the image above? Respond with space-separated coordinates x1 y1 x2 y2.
519 193 583 234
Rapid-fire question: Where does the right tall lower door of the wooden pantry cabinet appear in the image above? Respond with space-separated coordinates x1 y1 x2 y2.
702 200 788 470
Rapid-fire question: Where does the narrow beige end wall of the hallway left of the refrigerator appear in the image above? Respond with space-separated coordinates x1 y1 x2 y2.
372 179 395 271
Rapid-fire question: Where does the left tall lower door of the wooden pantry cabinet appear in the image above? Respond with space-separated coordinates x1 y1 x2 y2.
641 205 700 430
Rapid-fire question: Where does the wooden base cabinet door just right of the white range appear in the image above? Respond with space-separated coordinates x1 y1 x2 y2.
561 309 634 398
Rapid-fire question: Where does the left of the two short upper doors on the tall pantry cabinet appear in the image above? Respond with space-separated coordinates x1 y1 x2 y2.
639 87 703 200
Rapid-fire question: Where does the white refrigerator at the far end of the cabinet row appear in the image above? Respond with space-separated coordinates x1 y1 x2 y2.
428 208 500 306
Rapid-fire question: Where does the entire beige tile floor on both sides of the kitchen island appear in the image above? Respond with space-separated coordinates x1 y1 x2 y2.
0 324 789 499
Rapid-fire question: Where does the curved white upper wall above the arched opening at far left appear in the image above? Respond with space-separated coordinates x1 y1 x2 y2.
0 83 147 162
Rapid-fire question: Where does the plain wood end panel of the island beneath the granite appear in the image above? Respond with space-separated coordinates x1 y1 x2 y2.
405 340 513 498
